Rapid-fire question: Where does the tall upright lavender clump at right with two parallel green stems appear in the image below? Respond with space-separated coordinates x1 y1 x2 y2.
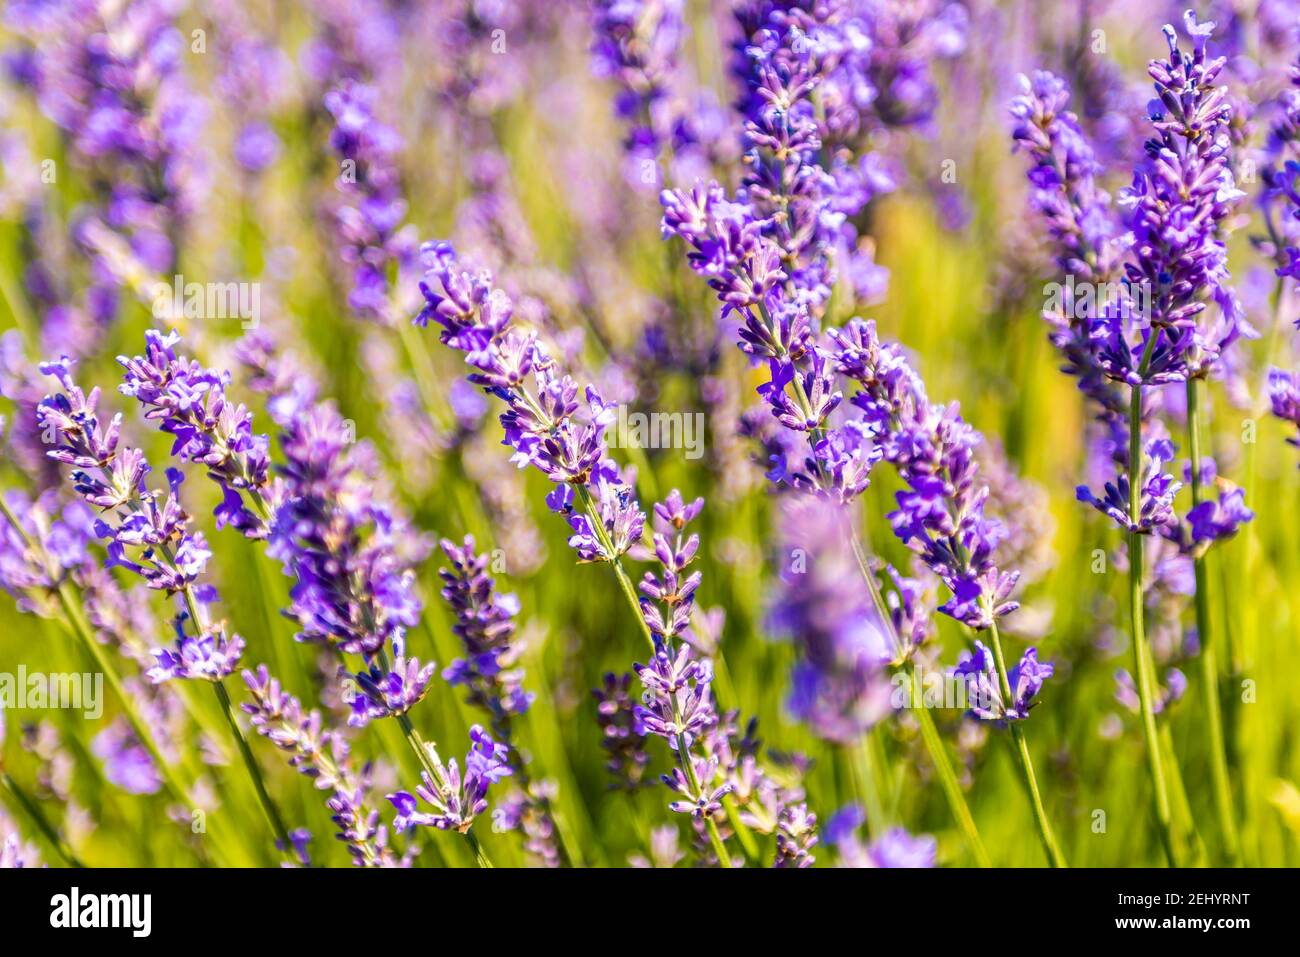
1011 12 1255 862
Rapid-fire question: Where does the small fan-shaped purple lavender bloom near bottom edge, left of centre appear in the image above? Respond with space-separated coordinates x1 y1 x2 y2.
389 724 512 833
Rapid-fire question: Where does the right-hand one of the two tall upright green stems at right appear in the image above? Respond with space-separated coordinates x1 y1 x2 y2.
1187 378 1242 865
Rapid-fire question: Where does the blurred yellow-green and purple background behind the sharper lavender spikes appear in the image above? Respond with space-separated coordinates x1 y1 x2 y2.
0 0 1300 866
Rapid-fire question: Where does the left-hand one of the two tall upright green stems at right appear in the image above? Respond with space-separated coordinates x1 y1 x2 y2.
1128 374 1178 867
